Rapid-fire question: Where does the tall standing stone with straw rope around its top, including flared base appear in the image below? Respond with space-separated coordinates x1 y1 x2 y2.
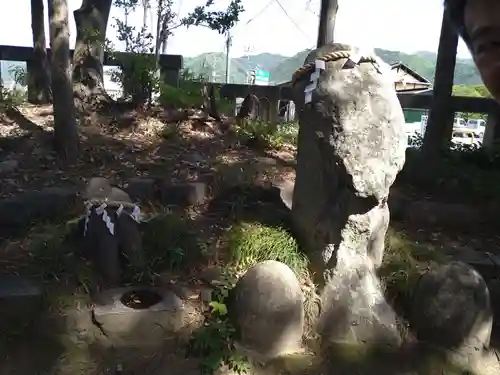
292 44 407 345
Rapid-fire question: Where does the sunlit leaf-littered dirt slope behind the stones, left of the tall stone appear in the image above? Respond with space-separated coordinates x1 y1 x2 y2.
0 105 292 196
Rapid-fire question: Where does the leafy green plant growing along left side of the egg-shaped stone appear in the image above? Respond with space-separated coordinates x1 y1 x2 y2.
188 271 249 375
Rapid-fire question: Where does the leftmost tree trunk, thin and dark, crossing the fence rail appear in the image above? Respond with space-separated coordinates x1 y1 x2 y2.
28 0 52 104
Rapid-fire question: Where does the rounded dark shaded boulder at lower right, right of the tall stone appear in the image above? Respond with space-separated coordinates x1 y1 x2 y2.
410 262 493 368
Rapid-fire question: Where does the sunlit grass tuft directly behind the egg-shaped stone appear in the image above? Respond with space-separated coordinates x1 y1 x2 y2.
227 223 308 277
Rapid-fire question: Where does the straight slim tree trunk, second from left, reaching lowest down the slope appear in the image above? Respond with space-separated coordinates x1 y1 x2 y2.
48 0 78 162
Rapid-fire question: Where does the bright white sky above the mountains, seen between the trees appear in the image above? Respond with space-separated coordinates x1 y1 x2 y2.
0 0 470 58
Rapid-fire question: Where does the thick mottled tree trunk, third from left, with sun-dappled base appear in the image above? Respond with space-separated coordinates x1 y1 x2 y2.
73 0 112 108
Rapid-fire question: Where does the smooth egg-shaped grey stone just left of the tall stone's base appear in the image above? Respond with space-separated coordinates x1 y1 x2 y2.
229 260 304 359
